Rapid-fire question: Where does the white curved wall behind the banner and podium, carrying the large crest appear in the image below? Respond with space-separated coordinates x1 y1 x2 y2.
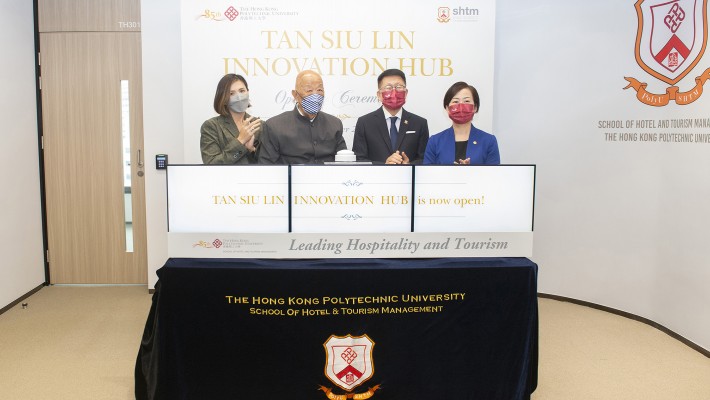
142 0 710 349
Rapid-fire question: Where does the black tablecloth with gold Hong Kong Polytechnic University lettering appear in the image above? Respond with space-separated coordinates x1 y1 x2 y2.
135 258 538 400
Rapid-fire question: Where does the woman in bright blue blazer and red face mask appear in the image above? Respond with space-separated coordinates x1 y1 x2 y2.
424 82 500 165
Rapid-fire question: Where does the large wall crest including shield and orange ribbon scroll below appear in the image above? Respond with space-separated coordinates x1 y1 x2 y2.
624 0 710 107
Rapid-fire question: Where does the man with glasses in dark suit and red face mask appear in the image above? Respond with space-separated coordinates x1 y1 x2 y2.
353 69 429 164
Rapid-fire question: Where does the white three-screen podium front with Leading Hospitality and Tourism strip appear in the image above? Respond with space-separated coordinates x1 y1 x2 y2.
167 165 535 258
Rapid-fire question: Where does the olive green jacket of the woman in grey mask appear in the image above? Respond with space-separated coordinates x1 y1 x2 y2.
200 114 261 164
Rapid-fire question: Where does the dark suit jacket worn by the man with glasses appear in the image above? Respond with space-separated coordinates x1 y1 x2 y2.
353 107 429 164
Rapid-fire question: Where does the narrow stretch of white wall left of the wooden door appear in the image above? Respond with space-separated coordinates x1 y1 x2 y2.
0 0 44 308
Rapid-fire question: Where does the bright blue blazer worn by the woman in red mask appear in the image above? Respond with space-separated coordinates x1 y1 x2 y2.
424 124 500 165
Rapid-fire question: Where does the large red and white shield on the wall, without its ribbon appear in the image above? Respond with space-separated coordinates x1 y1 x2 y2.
635 0 708 85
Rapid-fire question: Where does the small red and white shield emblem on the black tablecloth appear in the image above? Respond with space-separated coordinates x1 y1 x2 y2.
323 334 375 392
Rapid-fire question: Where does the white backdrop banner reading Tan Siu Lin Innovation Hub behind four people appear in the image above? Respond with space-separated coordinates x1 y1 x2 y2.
182 0 496 164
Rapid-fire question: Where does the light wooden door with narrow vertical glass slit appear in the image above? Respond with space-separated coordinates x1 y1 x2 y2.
40 32 147 284
